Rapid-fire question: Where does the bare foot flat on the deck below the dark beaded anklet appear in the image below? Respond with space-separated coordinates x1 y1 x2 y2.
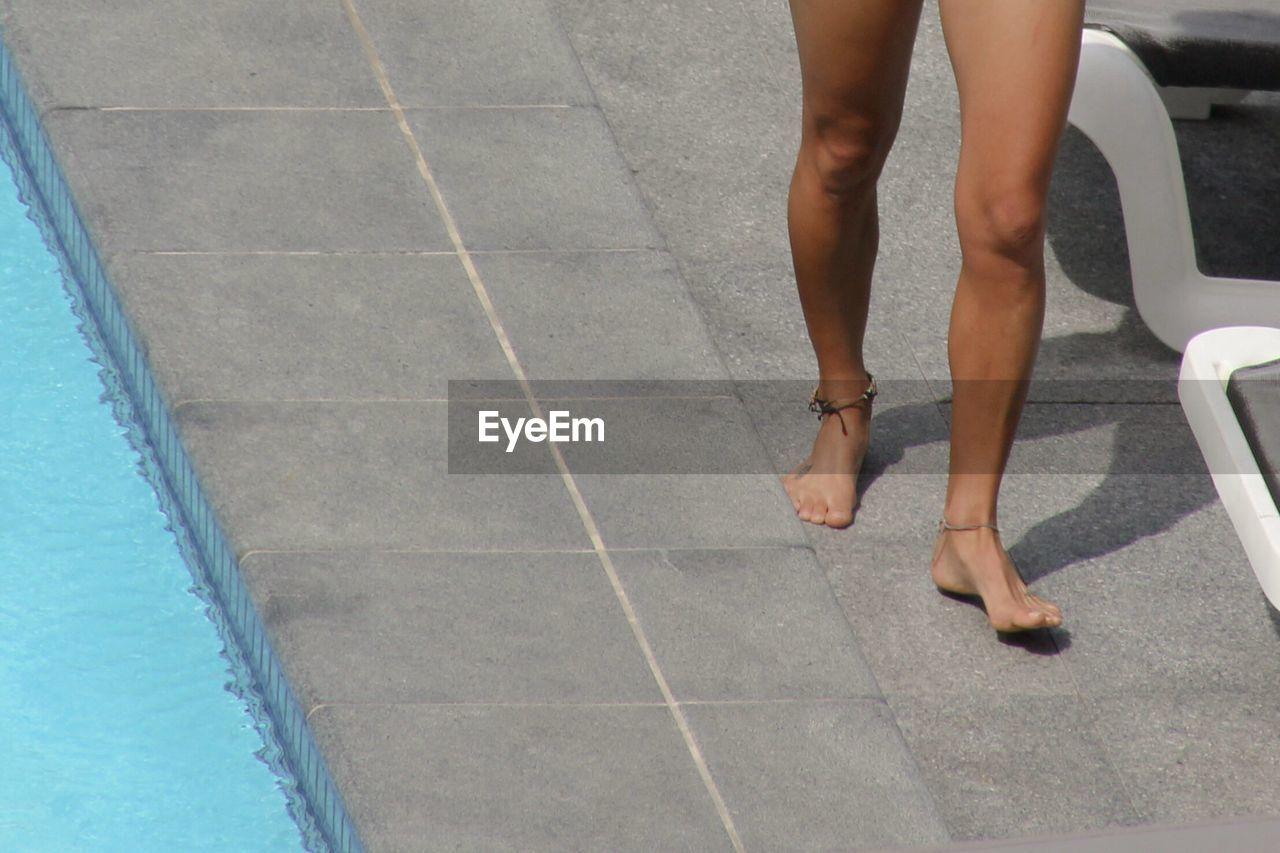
782 405 872 528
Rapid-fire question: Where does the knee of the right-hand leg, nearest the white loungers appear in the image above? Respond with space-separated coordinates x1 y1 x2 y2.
956 184 1044 266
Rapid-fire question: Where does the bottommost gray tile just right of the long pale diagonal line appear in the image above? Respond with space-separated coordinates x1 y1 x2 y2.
685 699 947 850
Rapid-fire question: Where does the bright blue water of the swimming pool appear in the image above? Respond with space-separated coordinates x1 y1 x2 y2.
0 151 314 835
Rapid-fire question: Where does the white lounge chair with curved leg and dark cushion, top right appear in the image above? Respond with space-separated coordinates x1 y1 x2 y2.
1069 0 1280 351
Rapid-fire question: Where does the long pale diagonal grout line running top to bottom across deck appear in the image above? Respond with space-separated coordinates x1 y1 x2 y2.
342 0 745 853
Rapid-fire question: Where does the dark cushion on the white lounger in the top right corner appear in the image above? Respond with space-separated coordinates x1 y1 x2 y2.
1084 0 1280 91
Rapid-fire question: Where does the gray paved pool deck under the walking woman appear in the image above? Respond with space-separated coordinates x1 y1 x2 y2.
0 0 1280 850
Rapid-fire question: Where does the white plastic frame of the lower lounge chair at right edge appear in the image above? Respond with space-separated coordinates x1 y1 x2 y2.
1178 327 1280 607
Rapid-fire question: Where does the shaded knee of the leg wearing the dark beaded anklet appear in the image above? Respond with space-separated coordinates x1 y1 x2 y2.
806 115 893 199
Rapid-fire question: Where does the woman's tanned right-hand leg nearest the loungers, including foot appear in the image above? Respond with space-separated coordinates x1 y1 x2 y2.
932 0 1084 630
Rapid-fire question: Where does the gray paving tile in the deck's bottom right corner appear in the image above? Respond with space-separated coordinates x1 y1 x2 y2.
1089 691 1280 824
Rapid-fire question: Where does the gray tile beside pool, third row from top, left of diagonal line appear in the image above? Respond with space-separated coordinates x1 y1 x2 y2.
108 252 511 406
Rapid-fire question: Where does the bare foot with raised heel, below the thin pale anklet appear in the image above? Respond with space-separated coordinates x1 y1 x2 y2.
931 528 1062 631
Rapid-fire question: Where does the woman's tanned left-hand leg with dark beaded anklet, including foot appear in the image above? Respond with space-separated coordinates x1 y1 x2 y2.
785 0 922 528
